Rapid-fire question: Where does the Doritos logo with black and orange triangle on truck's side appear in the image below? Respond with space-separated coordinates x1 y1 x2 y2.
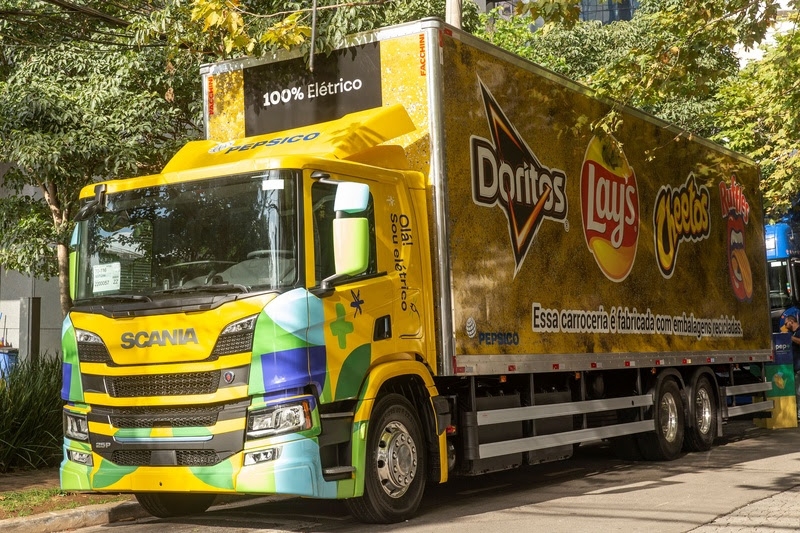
470 80 567 276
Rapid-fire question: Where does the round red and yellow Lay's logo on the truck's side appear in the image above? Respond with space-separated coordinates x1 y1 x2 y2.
581 136 639 282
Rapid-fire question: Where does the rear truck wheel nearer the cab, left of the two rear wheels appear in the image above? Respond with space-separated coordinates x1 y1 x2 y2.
639 378 684 461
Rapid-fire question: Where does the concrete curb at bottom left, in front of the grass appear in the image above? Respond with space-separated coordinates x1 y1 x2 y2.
0 502 150 533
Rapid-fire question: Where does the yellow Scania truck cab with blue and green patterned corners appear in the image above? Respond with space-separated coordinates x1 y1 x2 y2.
62 106 446 514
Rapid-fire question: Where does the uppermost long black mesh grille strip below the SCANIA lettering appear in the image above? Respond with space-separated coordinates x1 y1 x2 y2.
105 370 220 398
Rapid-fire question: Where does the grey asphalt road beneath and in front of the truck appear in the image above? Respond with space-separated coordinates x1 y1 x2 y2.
69 421 800 533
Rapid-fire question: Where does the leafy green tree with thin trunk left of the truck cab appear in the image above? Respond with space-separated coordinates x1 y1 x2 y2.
0 2 201 314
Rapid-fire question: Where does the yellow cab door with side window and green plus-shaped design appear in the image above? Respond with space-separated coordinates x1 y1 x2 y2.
306 175 396 403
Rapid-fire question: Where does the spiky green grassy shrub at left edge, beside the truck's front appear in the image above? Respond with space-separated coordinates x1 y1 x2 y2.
0 356 64 472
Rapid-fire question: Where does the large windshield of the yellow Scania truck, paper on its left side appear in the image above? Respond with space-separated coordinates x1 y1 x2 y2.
75 170 299 301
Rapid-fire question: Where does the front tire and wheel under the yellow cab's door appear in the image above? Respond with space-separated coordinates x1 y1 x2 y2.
346 394 428 524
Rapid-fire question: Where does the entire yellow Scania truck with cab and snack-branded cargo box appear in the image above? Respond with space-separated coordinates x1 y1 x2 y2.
61 19 776 522
